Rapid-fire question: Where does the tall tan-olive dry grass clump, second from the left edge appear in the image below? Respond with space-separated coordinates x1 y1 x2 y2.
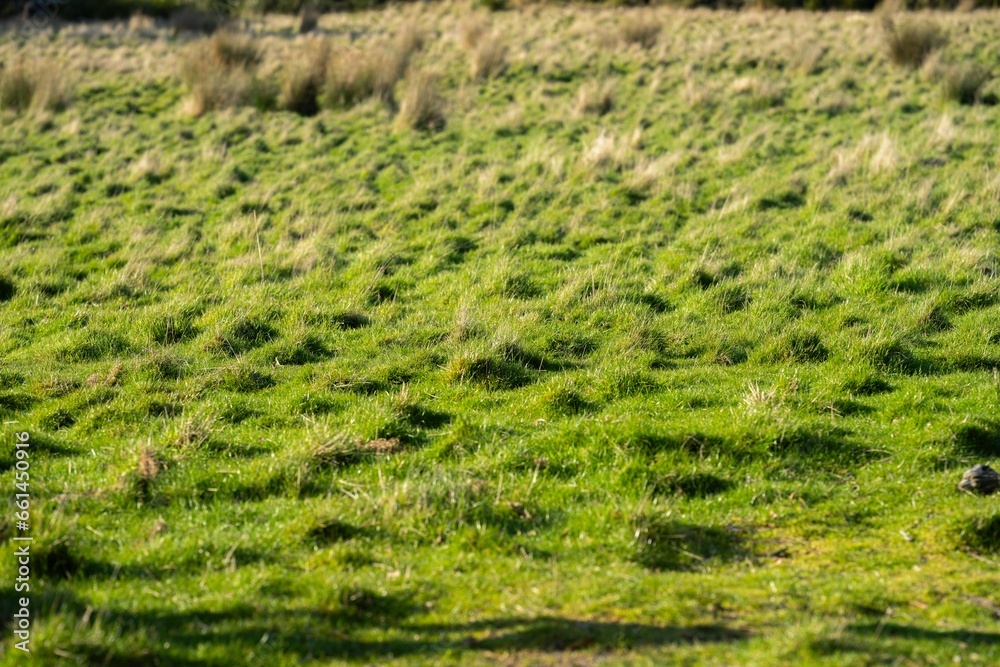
180 33 262 116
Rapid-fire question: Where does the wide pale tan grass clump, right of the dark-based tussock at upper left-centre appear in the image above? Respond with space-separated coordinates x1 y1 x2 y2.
322 46 409 108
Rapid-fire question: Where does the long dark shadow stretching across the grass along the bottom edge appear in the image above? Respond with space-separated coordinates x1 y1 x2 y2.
0 589 749 667
